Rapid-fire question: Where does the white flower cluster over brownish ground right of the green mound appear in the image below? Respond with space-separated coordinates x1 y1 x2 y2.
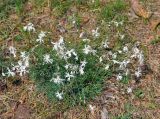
99 35 144 80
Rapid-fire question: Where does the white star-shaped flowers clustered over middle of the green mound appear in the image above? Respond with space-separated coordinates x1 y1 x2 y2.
38 36 96 100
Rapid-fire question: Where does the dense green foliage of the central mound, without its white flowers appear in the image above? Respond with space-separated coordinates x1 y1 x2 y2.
30 43 112 107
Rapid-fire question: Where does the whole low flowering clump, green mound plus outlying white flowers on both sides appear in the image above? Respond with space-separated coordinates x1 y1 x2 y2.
1 18 145 107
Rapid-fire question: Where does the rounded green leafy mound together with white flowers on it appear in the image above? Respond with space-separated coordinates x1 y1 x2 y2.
30 36 112 106
